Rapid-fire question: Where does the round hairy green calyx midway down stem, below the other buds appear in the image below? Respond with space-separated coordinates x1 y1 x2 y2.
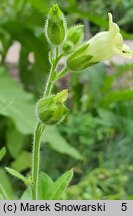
37 90 68 125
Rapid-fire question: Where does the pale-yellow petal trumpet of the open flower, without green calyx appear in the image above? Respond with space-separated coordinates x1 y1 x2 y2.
88 13 133 62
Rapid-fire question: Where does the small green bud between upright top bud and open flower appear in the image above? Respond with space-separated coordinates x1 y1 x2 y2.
62 25 84 54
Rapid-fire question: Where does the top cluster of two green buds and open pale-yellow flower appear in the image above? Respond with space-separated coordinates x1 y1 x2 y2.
45 4 133 71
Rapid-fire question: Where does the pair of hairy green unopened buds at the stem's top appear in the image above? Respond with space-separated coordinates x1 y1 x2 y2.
45 4 84 54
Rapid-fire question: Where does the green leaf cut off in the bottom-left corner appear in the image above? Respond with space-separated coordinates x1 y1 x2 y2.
0 168 16 200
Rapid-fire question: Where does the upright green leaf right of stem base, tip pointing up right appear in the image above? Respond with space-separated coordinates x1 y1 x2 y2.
47 169 73 200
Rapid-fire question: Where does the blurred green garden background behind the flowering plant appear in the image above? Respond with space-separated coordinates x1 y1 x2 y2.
0 0 133 200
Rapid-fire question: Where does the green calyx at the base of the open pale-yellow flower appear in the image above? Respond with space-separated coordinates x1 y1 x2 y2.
66 43 92 71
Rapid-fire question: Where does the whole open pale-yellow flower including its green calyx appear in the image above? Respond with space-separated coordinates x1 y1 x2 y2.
66 13 133 71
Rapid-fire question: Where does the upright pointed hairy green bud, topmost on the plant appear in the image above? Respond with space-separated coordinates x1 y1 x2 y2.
45 4 66 46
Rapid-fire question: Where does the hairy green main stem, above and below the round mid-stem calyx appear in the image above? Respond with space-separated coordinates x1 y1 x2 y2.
32 49 62 200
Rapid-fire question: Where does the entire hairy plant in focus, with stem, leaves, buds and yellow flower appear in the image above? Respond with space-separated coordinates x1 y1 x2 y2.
0 4 132 200
